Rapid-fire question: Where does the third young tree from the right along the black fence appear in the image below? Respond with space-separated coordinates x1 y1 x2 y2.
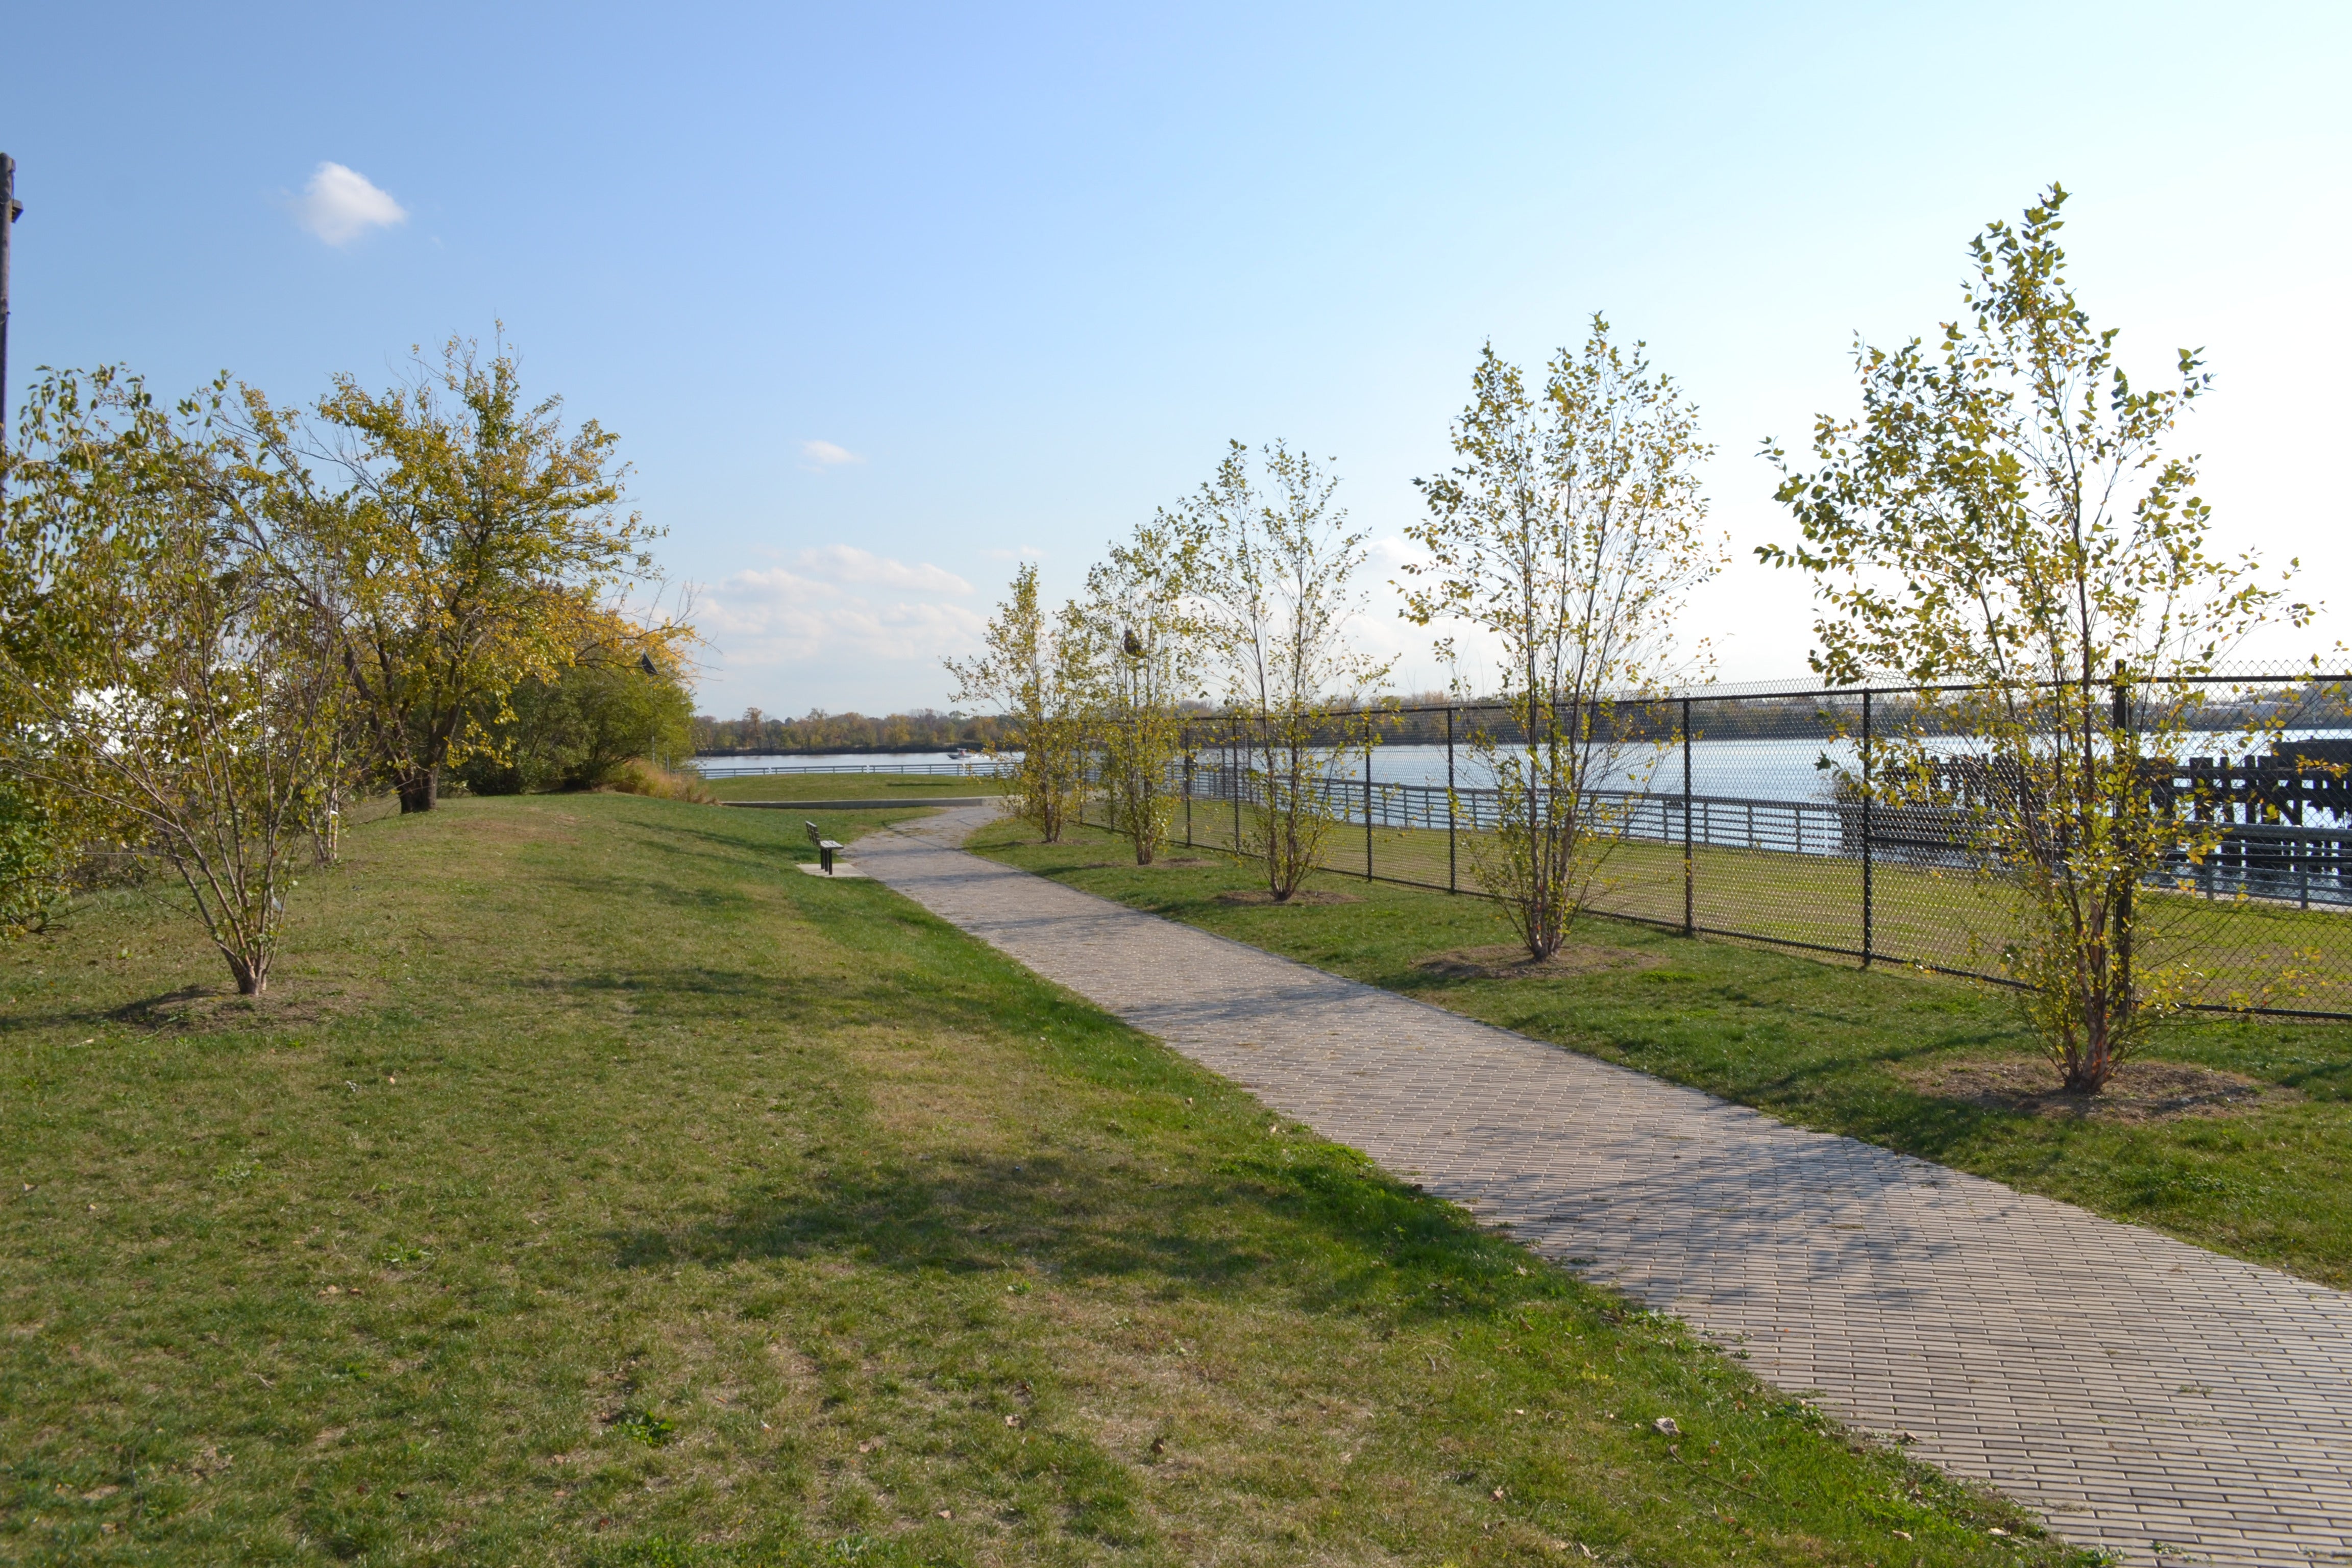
1190 442 1390 903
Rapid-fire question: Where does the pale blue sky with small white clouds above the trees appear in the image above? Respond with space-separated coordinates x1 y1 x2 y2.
0 3 2352 715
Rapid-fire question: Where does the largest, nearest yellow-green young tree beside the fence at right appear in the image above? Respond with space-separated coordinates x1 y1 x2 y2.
1759 186 2310 1093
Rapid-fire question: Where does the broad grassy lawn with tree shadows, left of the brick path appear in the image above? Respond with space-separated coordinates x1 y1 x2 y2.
0 795 2063 1568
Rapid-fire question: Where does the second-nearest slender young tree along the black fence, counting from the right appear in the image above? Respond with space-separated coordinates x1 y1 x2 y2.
1404 315 1724 959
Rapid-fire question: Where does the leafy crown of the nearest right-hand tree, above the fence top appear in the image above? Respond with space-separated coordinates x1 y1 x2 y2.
1759 186 2284 684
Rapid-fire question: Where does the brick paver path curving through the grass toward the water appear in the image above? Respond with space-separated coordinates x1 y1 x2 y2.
859 806 2352 1568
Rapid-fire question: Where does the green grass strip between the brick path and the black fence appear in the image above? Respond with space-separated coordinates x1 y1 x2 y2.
974 823 2352 1288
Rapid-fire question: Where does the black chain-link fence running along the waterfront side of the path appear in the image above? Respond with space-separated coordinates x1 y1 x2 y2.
1087 672 2352 1018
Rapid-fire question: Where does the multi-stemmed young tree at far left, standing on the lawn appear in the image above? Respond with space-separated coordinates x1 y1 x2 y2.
0 372 344 994
